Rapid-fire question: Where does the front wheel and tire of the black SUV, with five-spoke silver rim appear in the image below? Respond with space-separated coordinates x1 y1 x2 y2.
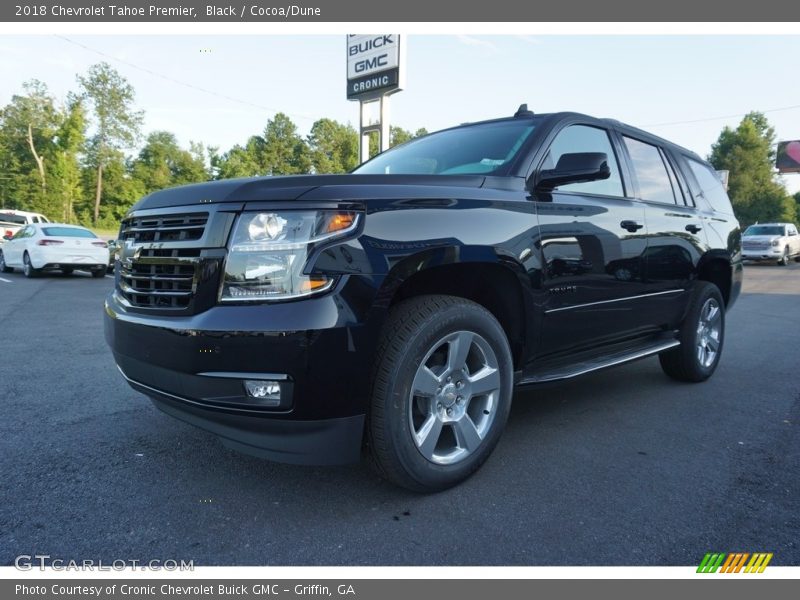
367 296 514 492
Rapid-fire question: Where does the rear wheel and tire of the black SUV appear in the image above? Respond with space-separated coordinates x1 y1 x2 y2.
658 281 725 383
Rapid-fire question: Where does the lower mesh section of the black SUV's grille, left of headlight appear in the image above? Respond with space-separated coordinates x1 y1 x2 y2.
119 248 200 309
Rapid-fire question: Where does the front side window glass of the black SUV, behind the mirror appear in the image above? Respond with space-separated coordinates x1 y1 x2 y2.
541 125 625 197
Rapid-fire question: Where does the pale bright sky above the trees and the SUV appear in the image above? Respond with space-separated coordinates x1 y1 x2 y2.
0 34 800 192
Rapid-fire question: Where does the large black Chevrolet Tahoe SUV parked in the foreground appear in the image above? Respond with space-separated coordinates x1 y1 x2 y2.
105 105 742 491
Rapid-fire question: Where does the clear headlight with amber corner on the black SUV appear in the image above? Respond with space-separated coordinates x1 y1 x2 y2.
220 210 358 302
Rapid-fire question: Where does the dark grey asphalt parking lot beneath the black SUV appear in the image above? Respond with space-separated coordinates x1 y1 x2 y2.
0 263 800 565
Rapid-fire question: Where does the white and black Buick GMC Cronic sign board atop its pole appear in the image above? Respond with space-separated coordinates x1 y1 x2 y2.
347 33 403 100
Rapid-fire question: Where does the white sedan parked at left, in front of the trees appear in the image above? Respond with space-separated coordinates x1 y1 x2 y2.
0 223 108 277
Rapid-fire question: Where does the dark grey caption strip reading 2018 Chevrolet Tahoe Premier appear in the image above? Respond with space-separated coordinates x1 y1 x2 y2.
0 0 800 23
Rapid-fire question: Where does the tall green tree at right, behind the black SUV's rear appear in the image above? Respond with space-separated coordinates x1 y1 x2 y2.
708 112 795 225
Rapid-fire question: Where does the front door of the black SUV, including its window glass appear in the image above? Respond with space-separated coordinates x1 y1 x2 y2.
534 123 647 357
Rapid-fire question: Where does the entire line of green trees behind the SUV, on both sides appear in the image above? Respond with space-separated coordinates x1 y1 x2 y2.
0 63 800 229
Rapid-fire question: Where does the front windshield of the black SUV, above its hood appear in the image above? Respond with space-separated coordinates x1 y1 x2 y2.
353 119 536 175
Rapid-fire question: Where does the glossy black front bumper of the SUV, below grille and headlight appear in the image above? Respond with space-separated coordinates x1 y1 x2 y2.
104 278 382 464
